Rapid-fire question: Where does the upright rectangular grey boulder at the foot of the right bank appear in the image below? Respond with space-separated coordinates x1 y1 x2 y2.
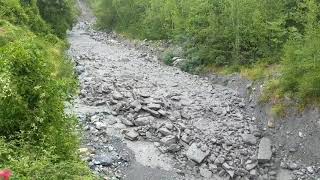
258 137 272 163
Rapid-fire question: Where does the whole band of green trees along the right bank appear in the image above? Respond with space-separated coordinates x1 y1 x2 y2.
90 0 320 106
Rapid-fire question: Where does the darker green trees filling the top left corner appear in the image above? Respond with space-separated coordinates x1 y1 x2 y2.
0 0 77 38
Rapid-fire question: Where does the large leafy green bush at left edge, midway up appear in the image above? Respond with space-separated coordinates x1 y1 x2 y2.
0 38 63 136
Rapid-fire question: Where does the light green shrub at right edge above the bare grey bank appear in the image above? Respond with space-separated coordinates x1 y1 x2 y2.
280 1 320 103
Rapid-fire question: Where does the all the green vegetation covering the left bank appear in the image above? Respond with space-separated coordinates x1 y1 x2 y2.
0 0 94 180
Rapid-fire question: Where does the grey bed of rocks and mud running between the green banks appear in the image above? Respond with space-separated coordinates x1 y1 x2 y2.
69 2 318 180
